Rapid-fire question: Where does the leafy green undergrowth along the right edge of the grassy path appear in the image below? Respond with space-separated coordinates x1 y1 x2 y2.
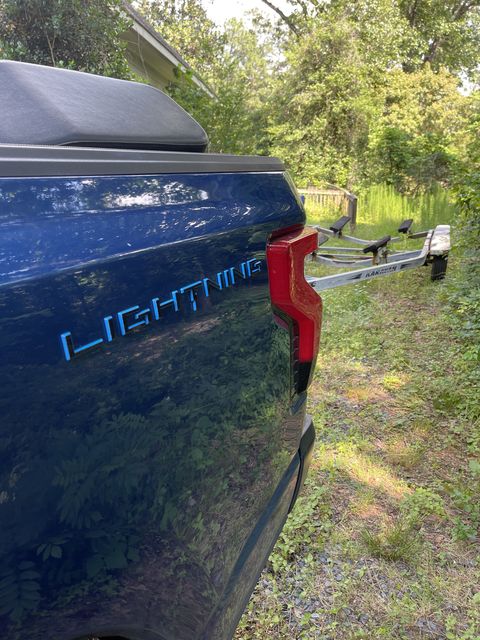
438 94 480 540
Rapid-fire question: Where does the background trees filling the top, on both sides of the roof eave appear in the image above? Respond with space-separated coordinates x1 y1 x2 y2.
0 0 480 192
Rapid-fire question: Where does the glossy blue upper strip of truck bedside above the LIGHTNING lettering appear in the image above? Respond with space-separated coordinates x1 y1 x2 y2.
0 173 299 284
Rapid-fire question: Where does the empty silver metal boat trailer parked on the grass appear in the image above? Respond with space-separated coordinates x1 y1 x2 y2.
306 216 451 291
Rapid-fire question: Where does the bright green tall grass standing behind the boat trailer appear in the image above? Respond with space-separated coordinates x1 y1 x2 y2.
306 184 453 237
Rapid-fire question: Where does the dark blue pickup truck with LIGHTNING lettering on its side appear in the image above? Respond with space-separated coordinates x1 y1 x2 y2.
0 61 321 640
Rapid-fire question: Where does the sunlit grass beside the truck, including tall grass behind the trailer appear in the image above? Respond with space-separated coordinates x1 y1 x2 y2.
235 188 480 640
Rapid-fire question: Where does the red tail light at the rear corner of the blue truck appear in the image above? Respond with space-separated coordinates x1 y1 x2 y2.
267 227 322 393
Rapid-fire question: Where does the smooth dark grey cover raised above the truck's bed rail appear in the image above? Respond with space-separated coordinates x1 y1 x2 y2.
0 60 208 152
